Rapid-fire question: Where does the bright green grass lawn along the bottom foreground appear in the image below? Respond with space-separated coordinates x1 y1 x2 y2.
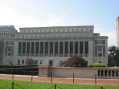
0 80 119 89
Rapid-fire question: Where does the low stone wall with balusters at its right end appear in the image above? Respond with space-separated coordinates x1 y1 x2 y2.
39 66 119 78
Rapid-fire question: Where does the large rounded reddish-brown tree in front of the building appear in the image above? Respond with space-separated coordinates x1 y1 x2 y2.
63 56 88 67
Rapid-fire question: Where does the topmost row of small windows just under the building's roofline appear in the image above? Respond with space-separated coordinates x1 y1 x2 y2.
20 27 93 33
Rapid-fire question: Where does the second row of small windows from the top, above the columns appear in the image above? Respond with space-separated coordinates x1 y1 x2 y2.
15 33 93 39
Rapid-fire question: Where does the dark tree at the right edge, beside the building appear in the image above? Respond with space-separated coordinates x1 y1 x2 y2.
108 46 119 66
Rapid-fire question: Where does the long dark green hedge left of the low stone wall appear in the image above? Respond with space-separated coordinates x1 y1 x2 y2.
0 65 38 75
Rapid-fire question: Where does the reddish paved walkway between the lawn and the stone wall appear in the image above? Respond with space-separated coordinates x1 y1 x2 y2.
0 74 119 85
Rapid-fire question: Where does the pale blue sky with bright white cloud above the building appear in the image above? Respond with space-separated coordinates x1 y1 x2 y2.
0 0 119 46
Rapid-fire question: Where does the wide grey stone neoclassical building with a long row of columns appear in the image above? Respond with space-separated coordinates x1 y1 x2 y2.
0 25 108 66
